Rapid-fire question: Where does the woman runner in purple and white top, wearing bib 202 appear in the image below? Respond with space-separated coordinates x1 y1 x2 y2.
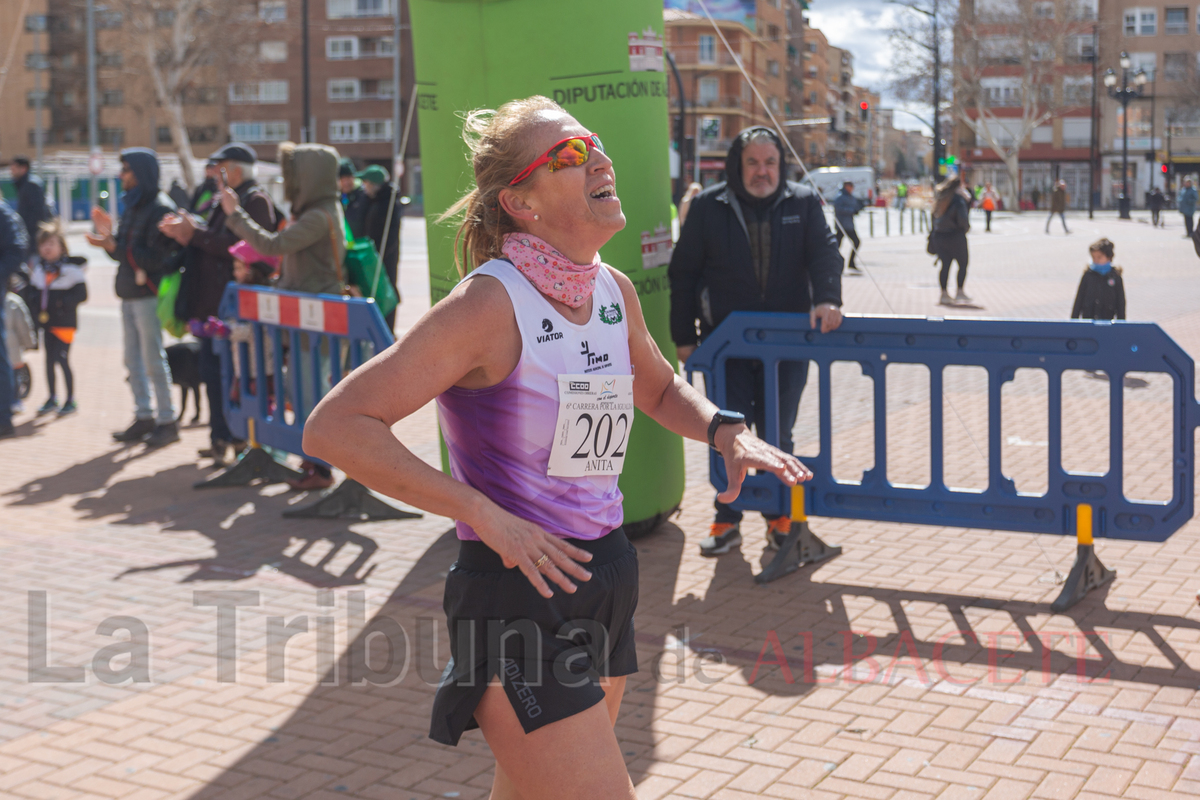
304 97 811 800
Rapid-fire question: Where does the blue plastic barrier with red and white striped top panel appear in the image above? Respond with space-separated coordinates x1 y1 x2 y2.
216 283 395 456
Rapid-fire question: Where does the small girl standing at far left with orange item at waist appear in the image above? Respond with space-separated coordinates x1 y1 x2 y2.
24 221 88 416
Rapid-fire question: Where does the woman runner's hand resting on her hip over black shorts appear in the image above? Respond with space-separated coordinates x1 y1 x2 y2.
472 507 592 599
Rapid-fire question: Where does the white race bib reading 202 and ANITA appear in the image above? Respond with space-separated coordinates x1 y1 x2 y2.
546 375 634 477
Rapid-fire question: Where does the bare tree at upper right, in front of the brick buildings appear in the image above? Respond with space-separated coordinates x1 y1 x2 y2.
954 0 1094 207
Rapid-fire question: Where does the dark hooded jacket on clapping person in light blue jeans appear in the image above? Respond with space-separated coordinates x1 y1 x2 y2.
110 148 182 300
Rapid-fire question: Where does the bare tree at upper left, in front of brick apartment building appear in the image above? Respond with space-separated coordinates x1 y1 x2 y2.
109 0 258 191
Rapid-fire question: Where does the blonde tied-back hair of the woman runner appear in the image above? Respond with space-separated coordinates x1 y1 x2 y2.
438 95 566 277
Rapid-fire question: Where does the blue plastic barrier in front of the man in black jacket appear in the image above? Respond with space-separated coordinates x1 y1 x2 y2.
686 313 1200 546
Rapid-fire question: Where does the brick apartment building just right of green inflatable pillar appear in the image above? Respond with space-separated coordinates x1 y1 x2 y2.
662 0 787 186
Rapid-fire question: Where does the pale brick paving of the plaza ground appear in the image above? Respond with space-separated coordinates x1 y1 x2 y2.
0 212 1200 800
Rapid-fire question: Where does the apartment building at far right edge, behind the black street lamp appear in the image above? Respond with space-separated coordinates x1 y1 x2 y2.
1098 0 1200 205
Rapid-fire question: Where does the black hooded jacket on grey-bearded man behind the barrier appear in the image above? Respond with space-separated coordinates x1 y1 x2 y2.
667 128 842 345
